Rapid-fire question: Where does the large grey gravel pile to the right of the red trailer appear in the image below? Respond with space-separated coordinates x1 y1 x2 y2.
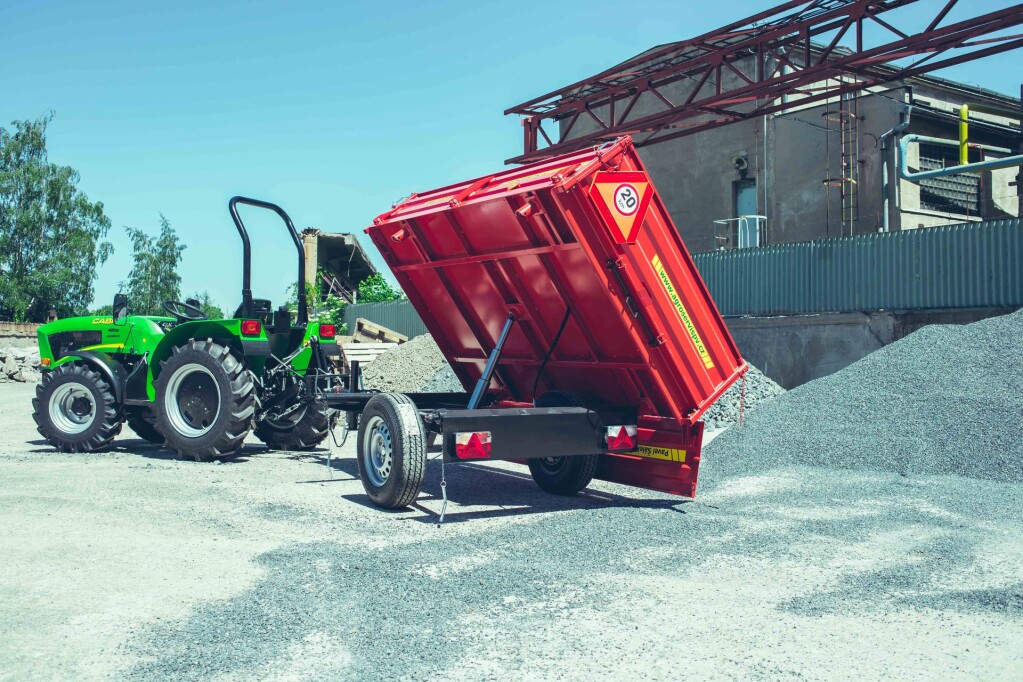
701 311 1023 484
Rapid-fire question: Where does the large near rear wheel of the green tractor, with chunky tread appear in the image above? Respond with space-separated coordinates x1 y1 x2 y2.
155 338 259 462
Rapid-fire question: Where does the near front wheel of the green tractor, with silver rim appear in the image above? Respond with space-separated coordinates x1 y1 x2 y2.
32 362 123 452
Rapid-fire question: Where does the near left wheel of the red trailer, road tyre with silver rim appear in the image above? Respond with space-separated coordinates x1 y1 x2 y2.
357 393 427 509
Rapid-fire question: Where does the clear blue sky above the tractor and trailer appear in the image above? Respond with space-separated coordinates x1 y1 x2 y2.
0 0 1023 309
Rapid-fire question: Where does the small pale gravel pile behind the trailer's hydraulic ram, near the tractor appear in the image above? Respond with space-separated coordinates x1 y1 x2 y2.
362 334 461 393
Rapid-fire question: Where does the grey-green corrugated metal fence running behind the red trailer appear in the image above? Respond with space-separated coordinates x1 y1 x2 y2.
345 219 1023 336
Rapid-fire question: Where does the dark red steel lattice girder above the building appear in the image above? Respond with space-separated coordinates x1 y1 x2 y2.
505 0 1023 164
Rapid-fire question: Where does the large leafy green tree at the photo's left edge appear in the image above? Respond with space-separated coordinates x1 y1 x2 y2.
0 113 114 322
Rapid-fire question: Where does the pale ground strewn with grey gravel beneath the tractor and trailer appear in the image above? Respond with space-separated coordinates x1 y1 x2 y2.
0 385 1023 680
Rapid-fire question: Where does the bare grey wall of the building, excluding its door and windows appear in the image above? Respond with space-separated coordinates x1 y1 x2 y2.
562 55 1018 253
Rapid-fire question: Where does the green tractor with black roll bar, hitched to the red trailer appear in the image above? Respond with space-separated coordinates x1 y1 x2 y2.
32 196 338 461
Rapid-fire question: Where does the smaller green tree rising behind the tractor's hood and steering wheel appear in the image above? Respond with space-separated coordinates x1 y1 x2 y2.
125 214 185 315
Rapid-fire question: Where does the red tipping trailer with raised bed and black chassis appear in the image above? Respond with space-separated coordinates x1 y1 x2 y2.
333 137 747 506
